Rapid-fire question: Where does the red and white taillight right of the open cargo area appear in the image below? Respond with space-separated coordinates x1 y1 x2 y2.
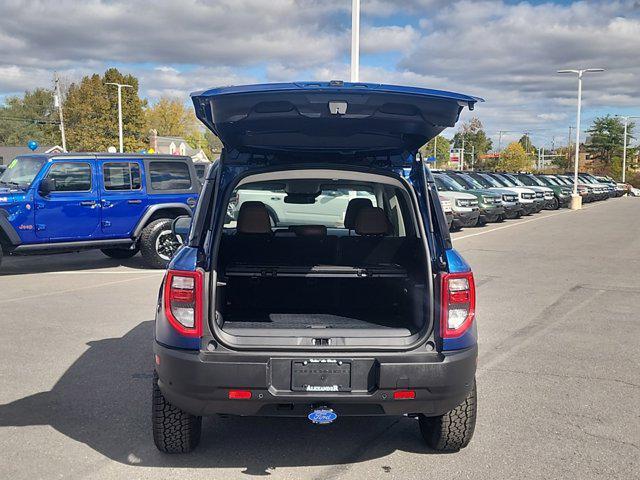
440 272 476 338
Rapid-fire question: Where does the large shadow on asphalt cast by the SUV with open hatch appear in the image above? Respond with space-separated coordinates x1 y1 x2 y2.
0 321 436 475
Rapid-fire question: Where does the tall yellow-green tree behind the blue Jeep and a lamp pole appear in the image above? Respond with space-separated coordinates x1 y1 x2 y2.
64 68 146 152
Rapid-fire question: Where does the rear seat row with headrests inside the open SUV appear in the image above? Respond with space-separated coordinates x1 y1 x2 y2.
221 202 417 268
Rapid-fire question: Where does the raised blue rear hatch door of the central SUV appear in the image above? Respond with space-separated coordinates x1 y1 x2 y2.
191 81 481 155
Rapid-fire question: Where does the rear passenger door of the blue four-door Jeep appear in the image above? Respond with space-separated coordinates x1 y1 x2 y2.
98 159 147 238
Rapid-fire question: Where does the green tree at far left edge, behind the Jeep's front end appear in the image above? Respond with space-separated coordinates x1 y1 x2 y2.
0 88 62 145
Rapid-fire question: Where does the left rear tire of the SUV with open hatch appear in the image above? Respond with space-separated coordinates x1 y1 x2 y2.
151 371 202 453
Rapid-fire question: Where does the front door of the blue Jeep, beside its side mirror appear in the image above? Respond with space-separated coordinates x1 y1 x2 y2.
35 158 100 242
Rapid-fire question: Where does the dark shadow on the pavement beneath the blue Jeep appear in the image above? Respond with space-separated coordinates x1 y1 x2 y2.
0 250 148 277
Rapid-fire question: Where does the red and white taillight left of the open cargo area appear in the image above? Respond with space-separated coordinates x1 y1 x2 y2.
164 270 203 337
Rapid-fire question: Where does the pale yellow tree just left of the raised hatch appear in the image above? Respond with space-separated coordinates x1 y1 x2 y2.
145 97 197 138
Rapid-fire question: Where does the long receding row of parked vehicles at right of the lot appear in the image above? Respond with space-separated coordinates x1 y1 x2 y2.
433 170 626 231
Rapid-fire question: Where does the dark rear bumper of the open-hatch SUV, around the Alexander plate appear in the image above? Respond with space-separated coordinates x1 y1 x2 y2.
154 343 478 417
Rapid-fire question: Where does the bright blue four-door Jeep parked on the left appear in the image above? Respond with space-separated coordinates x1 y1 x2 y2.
0 153 200 268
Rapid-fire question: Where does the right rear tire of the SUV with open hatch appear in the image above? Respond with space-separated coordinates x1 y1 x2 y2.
418 381 477 452
